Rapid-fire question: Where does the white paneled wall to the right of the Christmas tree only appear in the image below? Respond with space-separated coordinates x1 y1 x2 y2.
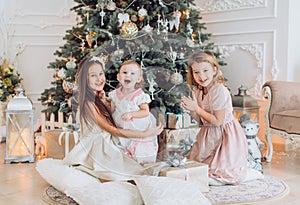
196 0 300 98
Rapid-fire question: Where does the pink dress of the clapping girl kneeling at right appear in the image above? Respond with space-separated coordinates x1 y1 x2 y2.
189 83 248 184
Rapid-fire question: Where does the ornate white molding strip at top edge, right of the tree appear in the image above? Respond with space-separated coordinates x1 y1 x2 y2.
201 0 267 14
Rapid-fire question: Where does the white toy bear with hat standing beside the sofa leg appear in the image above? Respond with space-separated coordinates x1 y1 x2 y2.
239 114 264 173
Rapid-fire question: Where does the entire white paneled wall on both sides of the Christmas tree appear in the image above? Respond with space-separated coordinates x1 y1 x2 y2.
0 0 300 121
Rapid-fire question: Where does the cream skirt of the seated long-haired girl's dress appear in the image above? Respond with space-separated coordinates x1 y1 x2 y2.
63 121 146 180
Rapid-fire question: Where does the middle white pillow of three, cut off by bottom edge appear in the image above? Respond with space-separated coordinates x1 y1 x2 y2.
66 182 143 205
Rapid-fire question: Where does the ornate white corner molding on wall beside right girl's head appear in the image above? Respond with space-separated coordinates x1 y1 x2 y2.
216 43 265 97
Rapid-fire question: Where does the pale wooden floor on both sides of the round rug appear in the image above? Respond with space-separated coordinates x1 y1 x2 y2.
0 143 300 205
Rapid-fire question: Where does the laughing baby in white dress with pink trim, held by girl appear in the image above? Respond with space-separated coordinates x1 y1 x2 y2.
109 60 158 164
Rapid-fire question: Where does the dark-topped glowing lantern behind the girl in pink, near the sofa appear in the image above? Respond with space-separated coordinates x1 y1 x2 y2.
232 85 259 122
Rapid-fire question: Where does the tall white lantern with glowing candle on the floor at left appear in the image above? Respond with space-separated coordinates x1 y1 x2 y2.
5 88 34 163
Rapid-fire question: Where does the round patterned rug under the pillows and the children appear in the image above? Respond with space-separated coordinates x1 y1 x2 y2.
42 176 289 205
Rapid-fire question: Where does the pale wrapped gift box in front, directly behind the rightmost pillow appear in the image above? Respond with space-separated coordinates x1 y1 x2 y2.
158 160 209 192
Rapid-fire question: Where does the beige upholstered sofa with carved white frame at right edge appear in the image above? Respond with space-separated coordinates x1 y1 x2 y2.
262 81 300 162
